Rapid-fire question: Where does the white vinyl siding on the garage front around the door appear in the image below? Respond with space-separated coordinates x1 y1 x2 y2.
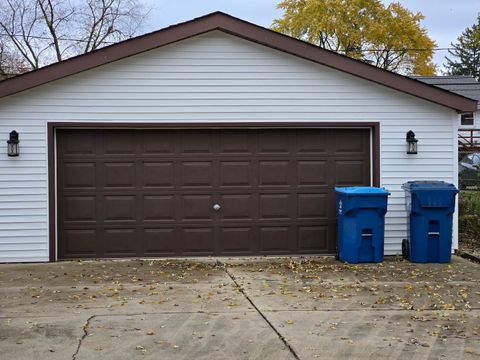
0 31 458 261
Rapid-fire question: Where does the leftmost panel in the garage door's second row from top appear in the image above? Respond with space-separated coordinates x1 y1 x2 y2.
59 162 96 190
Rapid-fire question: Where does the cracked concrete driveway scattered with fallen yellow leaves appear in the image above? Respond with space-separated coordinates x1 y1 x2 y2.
0 257 480 360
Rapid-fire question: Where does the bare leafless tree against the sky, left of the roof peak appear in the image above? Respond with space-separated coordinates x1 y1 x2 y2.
0 0 148 72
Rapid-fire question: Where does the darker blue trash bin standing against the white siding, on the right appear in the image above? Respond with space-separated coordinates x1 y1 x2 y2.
402 181 458 263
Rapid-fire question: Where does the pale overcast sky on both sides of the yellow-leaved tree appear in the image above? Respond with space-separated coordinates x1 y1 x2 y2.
140 0 480 73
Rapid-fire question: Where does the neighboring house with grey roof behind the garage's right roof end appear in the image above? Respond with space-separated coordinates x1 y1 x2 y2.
415 75 480 129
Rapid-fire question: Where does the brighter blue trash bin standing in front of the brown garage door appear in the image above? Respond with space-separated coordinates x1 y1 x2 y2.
335 187 389 264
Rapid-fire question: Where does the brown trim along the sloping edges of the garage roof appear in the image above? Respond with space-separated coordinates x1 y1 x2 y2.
0 12 477 112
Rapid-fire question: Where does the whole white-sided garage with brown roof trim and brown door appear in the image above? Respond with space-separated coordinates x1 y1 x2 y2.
0 13 477 262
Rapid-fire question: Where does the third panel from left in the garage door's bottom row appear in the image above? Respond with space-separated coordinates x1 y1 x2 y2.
143 228 178 256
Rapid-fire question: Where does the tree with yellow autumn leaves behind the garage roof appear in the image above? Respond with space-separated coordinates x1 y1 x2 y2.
272 0 436 75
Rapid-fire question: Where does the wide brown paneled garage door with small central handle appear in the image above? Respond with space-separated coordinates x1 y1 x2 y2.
57 129 370 259
